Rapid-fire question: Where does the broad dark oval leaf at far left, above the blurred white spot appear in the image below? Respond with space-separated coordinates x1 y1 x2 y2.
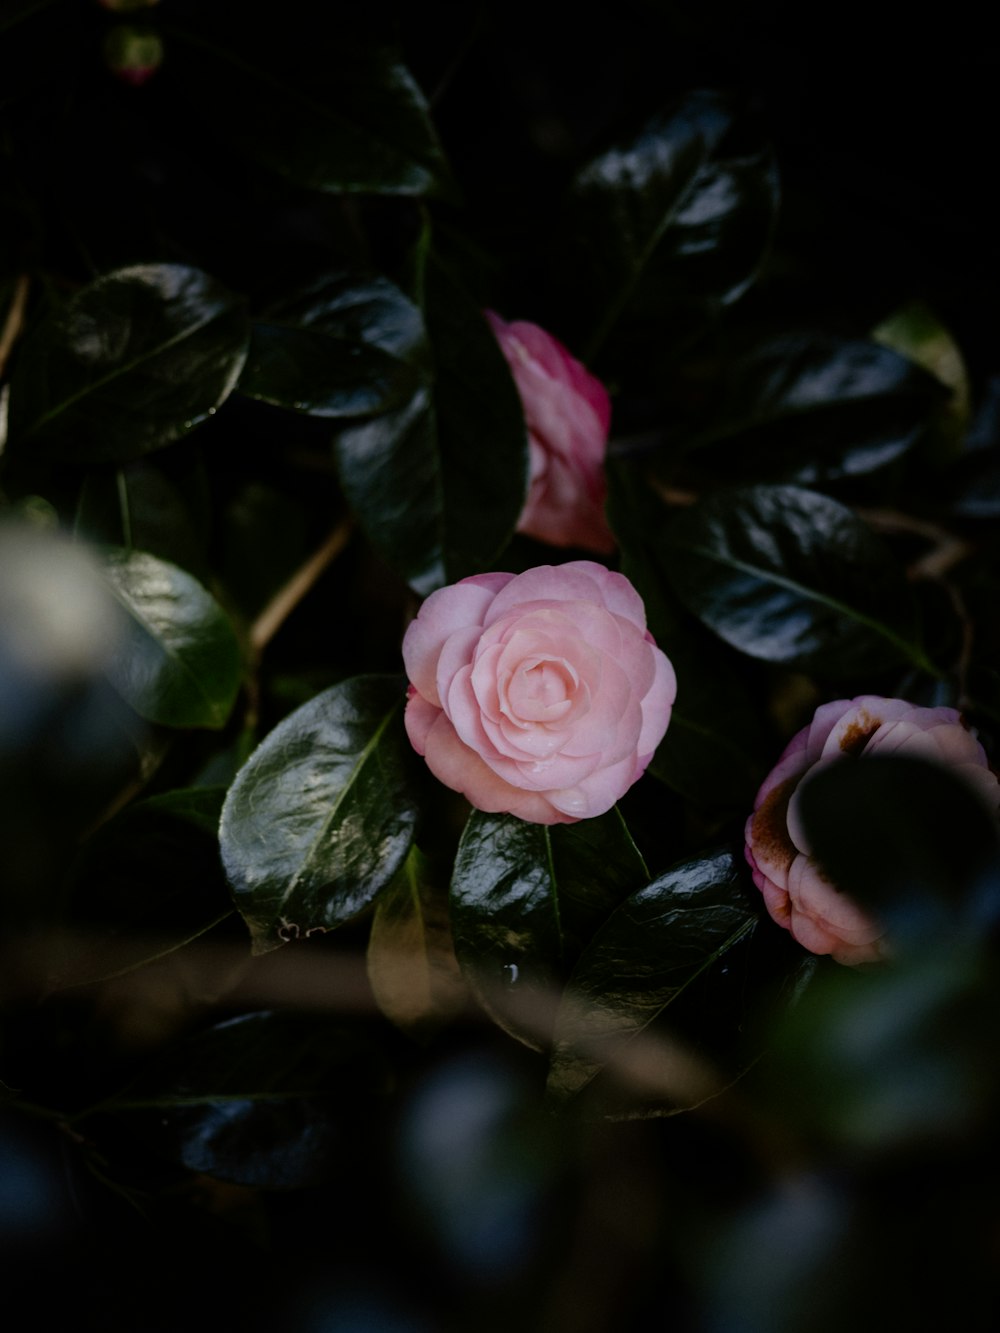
11 264 249 463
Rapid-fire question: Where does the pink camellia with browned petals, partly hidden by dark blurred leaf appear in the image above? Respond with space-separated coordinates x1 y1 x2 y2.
745 694 1000 964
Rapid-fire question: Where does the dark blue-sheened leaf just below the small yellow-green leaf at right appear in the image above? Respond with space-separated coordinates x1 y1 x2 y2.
669 332 948 485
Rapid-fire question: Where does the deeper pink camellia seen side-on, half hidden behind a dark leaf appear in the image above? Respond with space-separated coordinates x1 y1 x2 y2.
485 311 615 555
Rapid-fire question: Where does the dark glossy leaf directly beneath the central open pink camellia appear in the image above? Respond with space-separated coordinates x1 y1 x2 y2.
451 809 648 1049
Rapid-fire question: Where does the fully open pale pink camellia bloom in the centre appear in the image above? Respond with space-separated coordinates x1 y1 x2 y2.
403 560 677 824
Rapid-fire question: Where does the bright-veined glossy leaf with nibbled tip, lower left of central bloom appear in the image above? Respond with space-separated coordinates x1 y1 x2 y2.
220 676 416 953
